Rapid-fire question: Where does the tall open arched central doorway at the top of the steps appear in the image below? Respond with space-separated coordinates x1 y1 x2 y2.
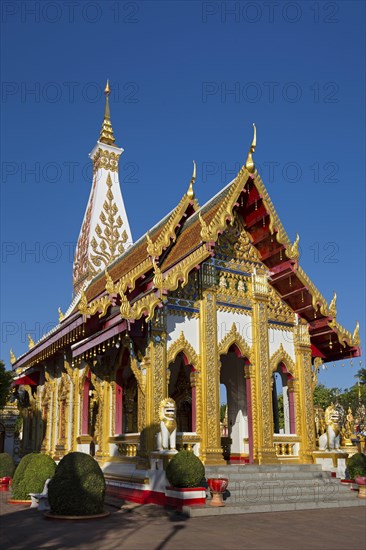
220 350 250 464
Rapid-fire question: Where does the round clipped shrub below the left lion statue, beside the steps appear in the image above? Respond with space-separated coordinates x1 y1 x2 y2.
166 451 205 487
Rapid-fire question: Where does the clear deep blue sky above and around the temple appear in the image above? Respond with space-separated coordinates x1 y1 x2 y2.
1 1 365 387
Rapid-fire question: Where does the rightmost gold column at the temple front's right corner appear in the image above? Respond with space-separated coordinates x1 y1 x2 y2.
295 322 315 464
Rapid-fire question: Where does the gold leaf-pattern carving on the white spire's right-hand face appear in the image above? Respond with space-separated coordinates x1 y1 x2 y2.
90 172 128 271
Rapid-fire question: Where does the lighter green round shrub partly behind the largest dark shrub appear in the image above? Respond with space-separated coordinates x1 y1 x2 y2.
12 453 56 500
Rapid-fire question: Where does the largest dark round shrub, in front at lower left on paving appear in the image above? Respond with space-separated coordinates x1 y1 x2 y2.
48 453 105 516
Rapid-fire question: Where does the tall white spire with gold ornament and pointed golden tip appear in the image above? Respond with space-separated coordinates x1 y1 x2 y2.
73 81 132 293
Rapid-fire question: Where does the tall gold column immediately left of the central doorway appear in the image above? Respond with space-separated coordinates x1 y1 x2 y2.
200 288 225 464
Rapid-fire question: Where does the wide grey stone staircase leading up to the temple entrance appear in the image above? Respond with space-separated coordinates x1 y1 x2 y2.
183 464 366 517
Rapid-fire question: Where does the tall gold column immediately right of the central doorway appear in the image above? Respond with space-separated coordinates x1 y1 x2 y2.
252 271 277 464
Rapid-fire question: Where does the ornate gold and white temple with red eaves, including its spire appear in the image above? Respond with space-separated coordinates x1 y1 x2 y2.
11 86 360 488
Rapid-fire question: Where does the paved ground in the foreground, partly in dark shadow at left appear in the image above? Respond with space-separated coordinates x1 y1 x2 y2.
0 492 366 550
